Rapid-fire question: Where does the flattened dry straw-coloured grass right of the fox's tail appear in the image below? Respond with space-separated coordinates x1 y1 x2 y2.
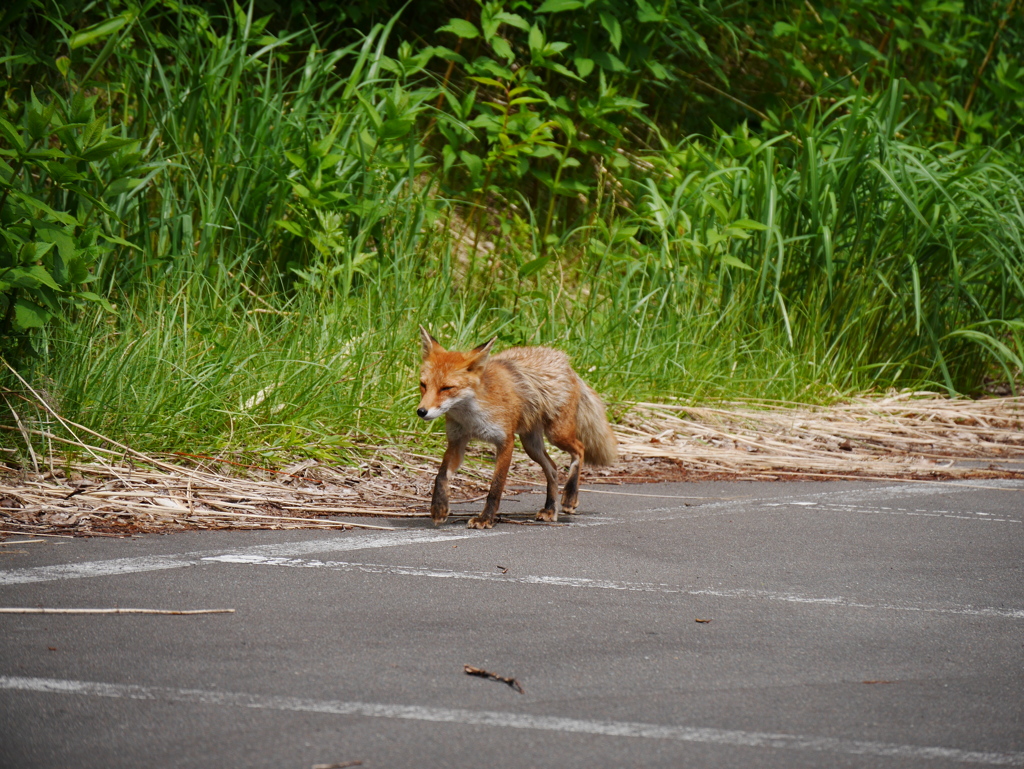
618 393 1024 479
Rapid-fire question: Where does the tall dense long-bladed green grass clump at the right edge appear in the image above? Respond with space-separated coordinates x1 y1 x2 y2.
644 81 1024 392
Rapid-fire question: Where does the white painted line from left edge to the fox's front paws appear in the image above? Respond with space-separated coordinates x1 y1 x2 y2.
0 529 479 585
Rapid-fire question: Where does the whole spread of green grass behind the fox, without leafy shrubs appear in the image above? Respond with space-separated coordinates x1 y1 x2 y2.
4 6 1024 461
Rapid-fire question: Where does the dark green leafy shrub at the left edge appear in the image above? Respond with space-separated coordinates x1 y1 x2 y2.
0 87 151 354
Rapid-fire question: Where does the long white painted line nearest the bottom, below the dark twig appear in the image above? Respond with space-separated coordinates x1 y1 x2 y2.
0 676 1024 766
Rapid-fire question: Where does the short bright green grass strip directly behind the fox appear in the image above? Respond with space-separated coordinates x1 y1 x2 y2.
41 264 837 461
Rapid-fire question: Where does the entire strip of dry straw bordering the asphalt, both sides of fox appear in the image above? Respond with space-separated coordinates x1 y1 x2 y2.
0 393 1024 536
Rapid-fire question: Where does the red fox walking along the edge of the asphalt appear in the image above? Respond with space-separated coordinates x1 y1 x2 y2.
416 326 617 528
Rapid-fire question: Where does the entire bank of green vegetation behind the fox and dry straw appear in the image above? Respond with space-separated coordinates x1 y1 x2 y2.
0 0 1024 464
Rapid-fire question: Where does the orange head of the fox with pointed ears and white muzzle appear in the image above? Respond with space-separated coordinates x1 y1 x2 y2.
416 326 498 420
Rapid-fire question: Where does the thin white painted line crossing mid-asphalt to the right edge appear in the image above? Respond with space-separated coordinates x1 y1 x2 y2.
203 553 1024 620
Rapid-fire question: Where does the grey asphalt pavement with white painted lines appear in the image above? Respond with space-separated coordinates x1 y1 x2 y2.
0 481 1024 769
